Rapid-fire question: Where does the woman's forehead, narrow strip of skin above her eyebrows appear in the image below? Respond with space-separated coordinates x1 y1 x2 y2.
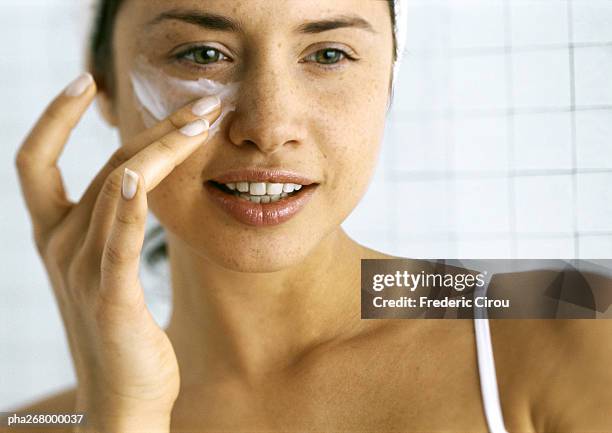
120 0 391 34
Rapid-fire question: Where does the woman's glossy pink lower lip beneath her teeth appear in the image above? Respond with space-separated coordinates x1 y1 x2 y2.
204 182 318 227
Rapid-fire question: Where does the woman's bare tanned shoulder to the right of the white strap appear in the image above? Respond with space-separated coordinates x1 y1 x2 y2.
482 269 612 432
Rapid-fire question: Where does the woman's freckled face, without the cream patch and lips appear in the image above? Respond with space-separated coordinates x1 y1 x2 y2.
113 0 393 272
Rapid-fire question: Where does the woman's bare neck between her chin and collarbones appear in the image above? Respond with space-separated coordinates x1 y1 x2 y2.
167 228 367 386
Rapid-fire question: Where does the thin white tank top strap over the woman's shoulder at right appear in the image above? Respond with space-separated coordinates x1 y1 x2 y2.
474 276 507 433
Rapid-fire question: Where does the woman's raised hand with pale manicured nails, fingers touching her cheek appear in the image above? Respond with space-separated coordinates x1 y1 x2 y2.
15 74 220 433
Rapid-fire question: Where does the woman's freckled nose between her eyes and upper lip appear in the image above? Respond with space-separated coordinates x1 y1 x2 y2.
229 67 305 154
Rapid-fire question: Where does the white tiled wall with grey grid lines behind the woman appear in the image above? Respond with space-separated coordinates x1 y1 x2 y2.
0 0 612 410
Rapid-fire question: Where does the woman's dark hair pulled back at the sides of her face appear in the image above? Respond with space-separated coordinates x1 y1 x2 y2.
89 0 397 268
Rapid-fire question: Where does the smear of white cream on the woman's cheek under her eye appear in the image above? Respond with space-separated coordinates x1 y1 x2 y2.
130 55 239 137
